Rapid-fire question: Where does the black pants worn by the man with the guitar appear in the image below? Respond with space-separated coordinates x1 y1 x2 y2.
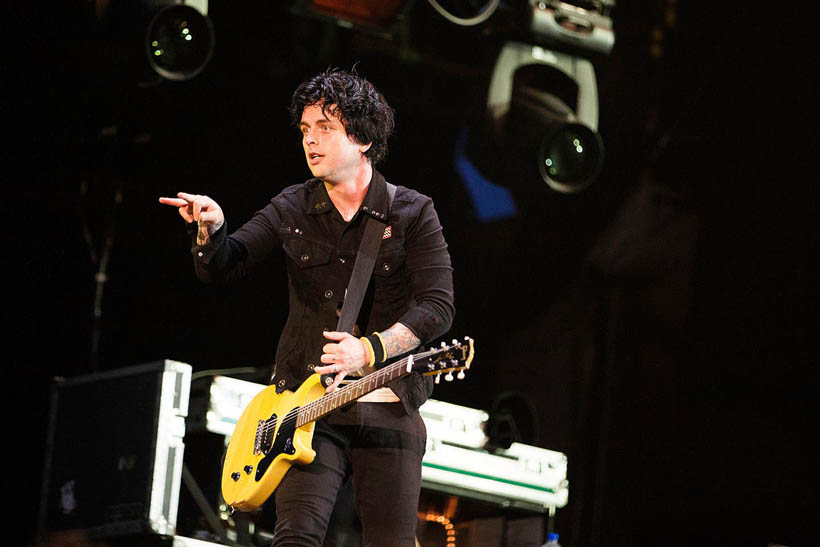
273 403 427 547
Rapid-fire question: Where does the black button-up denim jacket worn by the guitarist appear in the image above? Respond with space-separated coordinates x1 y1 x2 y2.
192 170 455 409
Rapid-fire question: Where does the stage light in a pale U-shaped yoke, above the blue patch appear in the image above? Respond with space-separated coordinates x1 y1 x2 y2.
473 42 604 194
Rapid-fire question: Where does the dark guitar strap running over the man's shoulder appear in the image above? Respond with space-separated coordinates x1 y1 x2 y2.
322 181 396 386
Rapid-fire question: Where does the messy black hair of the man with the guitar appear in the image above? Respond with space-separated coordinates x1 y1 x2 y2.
290 69 395 166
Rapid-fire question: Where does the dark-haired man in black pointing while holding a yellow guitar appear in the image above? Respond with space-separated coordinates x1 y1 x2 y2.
160 70 455 547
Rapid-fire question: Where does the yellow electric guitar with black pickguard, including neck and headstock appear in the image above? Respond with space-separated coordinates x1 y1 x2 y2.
222 338 475 511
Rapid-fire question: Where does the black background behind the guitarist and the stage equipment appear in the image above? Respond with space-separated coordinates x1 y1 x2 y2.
8 0 820 547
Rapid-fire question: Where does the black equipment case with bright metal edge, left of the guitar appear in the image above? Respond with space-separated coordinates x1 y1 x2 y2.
38 360 191 538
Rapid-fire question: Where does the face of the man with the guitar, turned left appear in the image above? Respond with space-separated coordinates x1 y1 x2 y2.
299 103 370 184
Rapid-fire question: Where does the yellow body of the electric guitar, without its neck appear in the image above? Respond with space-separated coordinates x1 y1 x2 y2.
222 374 325 511
